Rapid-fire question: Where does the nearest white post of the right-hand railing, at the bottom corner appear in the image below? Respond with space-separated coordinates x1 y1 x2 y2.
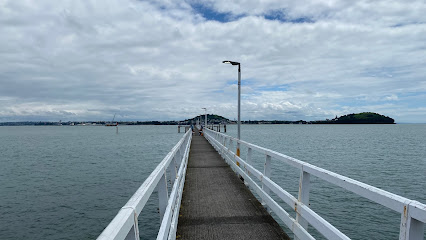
399 203 424 240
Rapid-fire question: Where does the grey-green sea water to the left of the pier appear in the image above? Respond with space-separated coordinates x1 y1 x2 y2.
0 126 183 240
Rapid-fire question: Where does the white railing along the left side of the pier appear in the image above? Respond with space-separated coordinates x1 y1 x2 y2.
97 131 192 240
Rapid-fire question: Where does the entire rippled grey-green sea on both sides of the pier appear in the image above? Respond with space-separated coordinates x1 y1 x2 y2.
0 124 426 239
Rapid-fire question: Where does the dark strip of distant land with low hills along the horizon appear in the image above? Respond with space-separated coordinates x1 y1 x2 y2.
0 112 395 126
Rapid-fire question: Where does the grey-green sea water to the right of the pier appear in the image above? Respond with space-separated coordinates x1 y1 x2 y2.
227 124 426 239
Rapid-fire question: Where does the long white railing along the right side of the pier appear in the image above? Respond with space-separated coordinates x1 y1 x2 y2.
204 129 426 240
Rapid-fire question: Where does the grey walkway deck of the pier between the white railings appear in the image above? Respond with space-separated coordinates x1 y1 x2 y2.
177 132 289 239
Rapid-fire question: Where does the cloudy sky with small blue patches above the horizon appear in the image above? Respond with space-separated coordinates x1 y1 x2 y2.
0 0 426 123
